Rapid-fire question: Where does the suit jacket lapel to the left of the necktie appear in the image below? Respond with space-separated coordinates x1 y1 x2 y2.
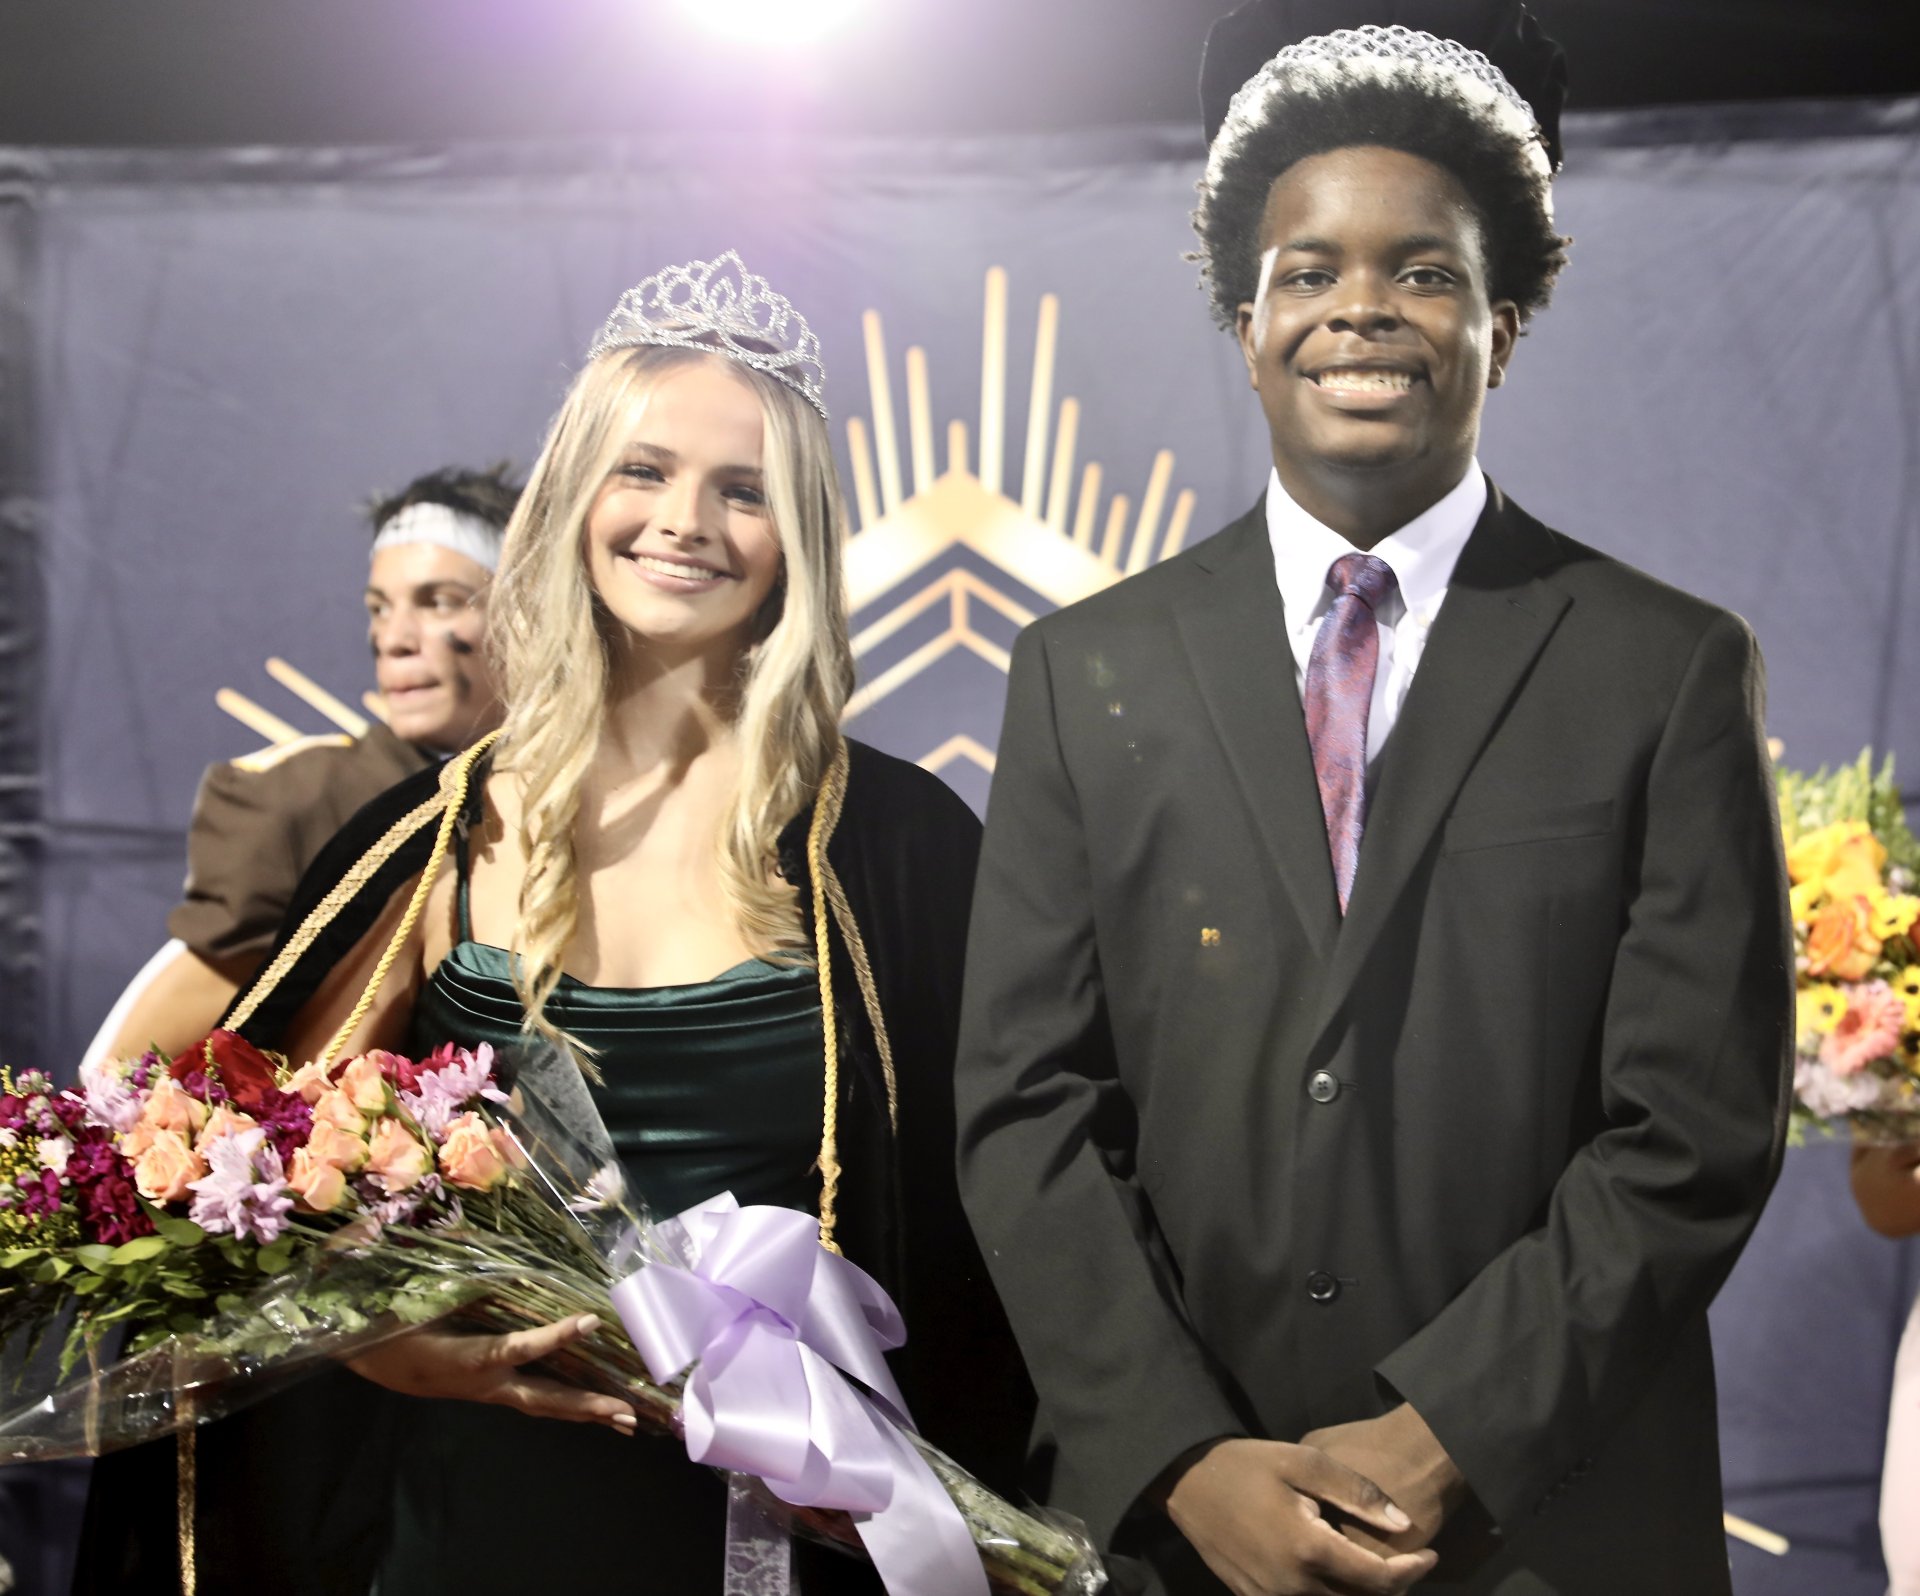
1173 501 1340 955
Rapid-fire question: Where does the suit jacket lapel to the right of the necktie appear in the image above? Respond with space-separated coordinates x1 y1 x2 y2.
1302 488 1569 1029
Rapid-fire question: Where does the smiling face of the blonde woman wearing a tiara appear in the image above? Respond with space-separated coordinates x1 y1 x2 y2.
586 355 781 663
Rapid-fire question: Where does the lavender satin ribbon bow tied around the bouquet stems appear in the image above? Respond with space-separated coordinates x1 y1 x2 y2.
612 1193 987 1596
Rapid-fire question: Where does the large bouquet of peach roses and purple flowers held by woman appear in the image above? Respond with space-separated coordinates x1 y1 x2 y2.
0 1031 1104 1596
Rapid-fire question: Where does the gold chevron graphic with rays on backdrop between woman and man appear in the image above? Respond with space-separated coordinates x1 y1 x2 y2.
847 267 1194 772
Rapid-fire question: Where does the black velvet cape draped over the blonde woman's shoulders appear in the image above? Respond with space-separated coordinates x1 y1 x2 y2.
73 741 1033 1596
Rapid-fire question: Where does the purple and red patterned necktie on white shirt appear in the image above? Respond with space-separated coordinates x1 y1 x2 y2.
1306 553 1394 914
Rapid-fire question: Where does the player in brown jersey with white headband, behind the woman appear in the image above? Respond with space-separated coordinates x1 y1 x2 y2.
106 467 520 1058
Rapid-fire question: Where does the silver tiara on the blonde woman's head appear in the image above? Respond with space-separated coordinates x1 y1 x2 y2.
588 250 828 421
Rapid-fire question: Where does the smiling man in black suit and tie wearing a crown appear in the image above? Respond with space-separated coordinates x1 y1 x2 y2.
960 0 1791 1596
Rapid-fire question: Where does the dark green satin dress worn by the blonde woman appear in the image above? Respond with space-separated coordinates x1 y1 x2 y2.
378 880 860 1596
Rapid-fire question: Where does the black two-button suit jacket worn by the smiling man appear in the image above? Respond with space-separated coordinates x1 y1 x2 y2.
960 490 1791 1596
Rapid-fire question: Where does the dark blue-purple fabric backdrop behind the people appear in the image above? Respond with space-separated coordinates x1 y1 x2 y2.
0 104 1920 1596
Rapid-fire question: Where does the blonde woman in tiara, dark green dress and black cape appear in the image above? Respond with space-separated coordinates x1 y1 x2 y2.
80 255 1025 1596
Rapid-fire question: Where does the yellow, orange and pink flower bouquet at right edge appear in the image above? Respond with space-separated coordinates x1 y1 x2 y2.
1778 751 1920 1141
